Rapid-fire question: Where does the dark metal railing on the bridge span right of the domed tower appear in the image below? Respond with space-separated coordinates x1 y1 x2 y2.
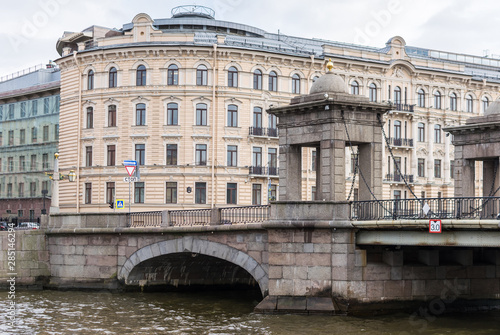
351 197 500 221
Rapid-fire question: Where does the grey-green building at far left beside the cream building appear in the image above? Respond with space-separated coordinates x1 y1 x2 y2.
0 64 60 221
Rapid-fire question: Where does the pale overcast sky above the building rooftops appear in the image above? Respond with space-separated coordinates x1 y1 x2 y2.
0 0 500 77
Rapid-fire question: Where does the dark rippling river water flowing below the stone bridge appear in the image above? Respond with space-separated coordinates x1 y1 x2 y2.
0 291 500 335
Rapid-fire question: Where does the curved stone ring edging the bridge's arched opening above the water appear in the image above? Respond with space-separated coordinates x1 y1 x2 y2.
118 237 269 296
